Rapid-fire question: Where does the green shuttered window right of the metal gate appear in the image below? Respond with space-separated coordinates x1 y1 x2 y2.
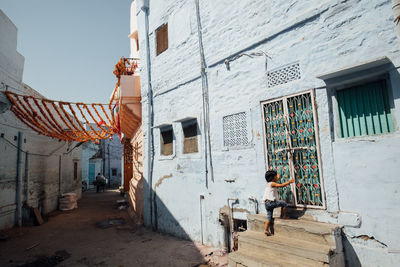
336 80 394 138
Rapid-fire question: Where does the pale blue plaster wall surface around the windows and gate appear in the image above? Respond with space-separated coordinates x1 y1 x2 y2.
137 0 400 266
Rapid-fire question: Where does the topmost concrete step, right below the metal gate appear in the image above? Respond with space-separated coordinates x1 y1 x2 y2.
247 214 343 249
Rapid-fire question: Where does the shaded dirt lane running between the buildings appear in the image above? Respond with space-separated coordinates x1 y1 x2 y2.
0 191 227 267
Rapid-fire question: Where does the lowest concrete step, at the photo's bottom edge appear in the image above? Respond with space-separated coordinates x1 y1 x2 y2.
228 249 328 267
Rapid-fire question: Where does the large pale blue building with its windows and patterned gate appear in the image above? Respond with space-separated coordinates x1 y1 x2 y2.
132 0 400 266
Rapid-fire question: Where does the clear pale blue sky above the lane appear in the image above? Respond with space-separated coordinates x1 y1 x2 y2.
0 0 132 103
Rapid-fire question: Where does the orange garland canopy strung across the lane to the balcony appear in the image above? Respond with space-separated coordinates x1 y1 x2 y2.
4 57 141 142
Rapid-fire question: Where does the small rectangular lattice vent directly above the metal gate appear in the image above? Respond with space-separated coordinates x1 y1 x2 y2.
267 63 301 88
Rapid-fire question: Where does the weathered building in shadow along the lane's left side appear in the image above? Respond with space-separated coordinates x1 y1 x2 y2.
0 10 82 229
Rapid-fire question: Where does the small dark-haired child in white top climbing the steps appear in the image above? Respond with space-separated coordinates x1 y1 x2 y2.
263 170 294 236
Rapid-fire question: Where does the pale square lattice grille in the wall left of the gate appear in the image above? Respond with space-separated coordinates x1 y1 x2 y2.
222 112 249 147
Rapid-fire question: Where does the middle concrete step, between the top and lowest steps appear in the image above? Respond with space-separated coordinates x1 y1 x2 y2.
239 231 335 263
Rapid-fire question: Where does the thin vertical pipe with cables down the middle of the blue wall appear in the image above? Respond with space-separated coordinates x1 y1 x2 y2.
194 0 214 188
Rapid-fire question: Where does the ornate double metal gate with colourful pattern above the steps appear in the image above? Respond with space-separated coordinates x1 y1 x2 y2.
261 91 325 208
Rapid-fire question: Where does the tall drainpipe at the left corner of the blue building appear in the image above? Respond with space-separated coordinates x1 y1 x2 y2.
140 0 157 230
